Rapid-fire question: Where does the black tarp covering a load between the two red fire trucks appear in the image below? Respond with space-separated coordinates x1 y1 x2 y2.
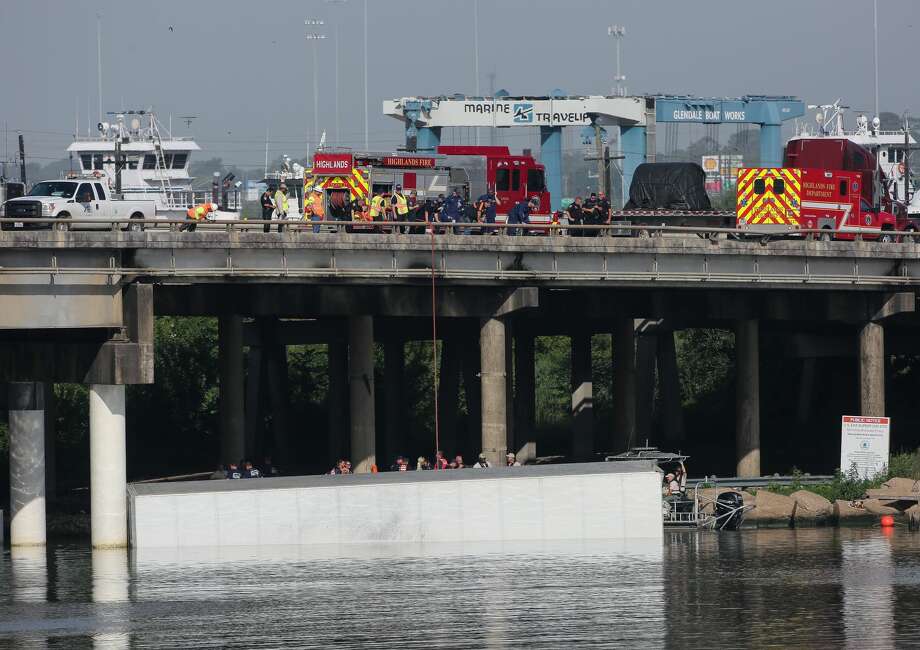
623 163 712 210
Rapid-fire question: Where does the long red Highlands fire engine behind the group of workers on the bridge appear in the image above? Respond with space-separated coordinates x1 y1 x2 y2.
304 146 551 224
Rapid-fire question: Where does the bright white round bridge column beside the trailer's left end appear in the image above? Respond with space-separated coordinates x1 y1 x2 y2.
89 384 128 548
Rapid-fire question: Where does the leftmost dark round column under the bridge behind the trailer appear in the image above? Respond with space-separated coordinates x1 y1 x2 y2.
218 316 248 466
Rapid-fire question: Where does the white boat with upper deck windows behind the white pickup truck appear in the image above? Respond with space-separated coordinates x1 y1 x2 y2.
67 110 241 219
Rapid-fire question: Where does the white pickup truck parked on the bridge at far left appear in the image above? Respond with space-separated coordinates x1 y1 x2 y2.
0 179 156 231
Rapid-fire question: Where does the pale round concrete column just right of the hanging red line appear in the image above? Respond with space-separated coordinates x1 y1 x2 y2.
479 318 508 466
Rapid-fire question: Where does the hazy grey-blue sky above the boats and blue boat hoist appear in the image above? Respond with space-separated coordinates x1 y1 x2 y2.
0 0 920 167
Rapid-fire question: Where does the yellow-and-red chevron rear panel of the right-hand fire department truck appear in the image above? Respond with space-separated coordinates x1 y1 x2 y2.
737 167 802 228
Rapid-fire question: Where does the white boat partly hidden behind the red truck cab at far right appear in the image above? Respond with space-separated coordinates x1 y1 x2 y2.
790 99 920 217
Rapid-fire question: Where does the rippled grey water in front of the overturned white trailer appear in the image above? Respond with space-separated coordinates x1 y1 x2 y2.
0 530 920 648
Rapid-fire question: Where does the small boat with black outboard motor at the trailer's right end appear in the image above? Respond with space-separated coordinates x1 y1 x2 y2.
604 446 753 530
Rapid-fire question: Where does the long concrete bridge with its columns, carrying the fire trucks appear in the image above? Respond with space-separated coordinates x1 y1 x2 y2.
0 225 920 546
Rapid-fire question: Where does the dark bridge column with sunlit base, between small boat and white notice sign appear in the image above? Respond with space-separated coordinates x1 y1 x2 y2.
735 320 760 477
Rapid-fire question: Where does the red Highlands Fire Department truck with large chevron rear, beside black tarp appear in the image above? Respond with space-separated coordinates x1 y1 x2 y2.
737 167 897 242
